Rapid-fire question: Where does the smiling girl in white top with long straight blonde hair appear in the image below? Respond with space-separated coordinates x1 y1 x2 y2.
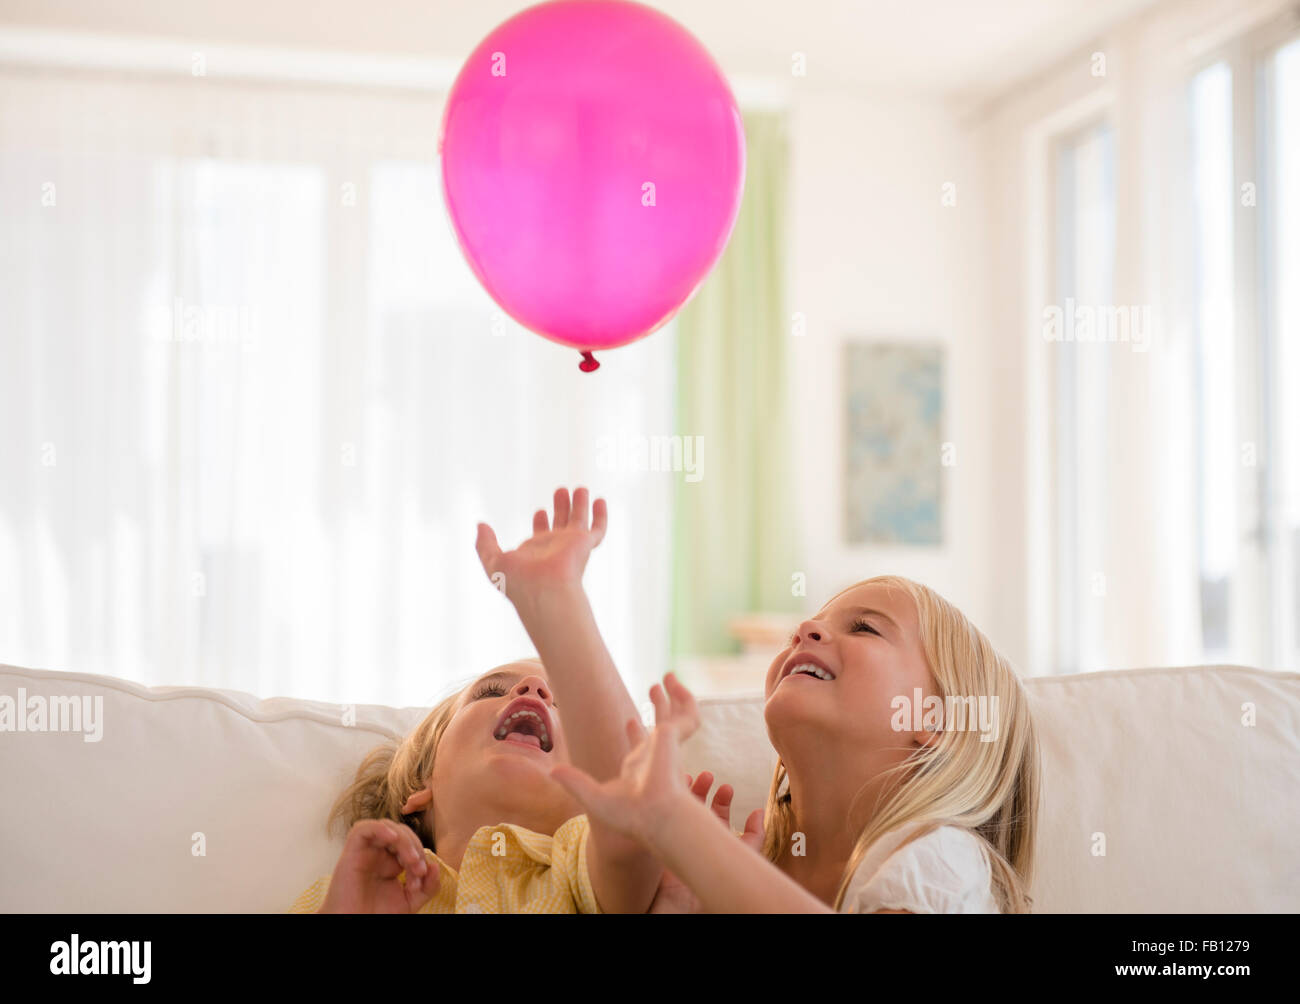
553 576 1040 913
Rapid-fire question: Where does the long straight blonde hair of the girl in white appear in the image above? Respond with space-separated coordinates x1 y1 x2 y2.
763 575 1041 913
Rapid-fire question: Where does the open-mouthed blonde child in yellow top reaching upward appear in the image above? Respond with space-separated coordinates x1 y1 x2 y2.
293 488 662 913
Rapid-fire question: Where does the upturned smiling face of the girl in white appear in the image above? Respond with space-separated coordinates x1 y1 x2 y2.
764 583 939 760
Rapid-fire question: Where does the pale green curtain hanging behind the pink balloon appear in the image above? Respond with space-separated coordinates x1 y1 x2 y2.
672 113 801 655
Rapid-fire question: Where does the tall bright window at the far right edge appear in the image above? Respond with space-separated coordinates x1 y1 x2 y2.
1188 31 1300 667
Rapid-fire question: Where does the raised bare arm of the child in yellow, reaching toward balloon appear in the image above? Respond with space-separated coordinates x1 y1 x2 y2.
476 488 662 913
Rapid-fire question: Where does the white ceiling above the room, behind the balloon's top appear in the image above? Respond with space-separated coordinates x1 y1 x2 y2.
0 0 1156 101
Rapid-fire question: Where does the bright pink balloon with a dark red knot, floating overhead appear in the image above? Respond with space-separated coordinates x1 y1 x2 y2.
438 0 745 368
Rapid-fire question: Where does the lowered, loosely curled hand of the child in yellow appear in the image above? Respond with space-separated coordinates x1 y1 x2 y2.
319 819 439 913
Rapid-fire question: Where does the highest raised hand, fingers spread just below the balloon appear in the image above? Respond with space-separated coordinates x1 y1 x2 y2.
475 488 608 603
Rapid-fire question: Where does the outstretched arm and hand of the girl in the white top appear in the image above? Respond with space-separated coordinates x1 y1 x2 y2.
551 674 832 913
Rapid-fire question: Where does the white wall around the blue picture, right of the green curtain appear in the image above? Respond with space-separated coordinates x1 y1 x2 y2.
789 85 1018 654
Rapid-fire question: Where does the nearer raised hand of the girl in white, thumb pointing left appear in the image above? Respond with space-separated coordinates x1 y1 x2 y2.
551 672 707 843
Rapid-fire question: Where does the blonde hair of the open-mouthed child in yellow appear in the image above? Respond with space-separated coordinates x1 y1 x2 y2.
325 691 462 851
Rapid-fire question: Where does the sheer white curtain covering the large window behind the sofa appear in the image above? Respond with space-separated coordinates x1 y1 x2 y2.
0 70 681 704
